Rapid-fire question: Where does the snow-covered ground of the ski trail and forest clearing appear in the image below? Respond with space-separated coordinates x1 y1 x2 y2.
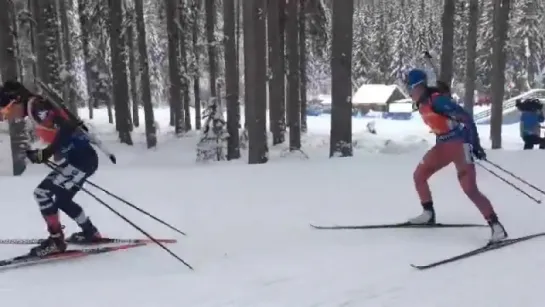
0 109 545 307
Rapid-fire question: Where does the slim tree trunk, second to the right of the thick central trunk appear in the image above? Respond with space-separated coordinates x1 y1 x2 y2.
286 0 300 150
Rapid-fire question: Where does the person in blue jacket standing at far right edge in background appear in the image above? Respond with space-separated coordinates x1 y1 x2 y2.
516 99 545 150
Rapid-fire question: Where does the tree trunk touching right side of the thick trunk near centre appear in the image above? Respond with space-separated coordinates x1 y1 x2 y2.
267 1 285 145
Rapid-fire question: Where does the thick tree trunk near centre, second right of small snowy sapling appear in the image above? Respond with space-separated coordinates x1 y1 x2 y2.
242 0 268 164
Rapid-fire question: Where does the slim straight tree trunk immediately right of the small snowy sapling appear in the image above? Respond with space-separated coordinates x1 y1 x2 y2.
223 0 240 160
